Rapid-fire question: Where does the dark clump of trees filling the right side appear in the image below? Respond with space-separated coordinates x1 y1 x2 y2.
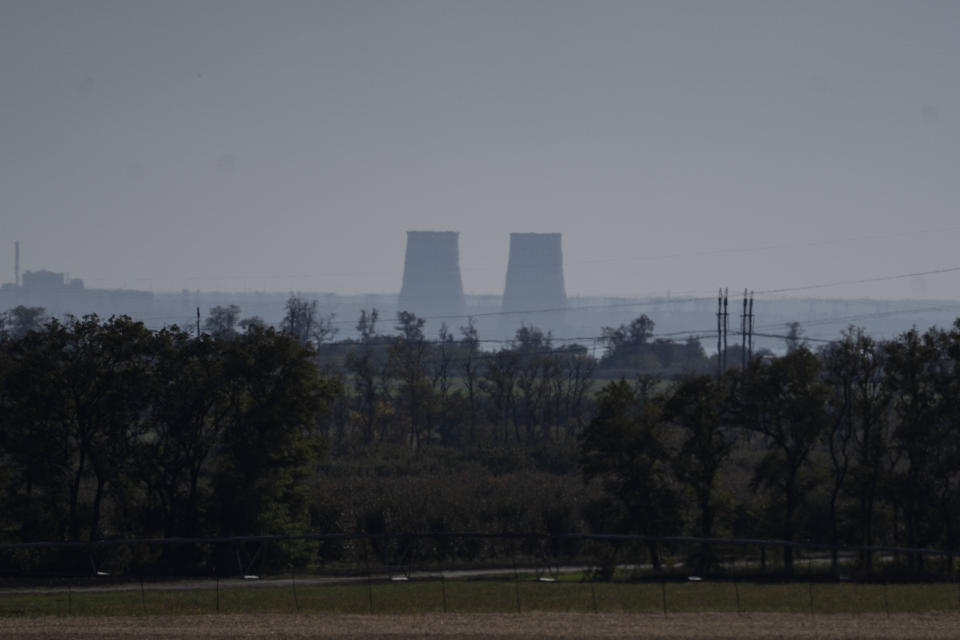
581 328 960 572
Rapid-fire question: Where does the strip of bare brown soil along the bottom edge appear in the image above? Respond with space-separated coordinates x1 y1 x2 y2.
0 613 960 640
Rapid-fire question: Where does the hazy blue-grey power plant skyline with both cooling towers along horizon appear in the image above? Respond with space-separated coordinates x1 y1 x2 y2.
0 238 956 350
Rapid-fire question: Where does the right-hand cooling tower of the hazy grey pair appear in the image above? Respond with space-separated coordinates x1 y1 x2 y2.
503 233 567 318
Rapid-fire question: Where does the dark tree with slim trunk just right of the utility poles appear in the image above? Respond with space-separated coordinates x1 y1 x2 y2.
738 347 828 574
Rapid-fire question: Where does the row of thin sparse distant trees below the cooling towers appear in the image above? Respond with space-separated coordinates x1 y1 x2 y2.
319 310 596 451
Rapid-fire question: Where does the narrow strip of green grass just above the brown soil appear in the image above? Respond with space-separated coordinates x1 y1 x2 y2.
0 580 960 617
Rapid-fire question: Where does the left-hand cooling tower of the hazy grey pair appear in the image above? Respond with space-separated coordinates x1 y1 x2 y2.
400 231 463 326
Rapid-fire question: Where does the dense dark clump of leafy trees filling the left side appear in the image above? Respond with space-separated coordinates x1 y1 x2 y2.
0 317 338 541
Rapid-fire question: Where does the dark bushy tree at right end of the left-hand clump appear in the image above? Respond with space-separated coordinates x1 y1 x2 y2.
215 329 337 535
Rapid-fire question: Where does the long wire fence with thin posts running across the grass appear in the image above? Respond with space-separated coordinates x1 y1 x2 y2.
0 533 960 616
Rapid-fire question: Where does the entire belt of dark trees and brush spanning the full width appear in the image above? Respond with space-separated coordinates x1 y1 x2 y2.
0 297 960 570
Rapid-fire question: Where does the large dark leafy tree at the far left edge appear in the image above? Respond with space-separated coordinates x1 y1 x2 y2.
4 316 151 540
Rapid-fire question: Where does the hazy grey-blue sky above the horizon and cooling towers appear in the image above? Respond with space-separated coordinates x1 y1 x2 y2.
0 0 960 298
